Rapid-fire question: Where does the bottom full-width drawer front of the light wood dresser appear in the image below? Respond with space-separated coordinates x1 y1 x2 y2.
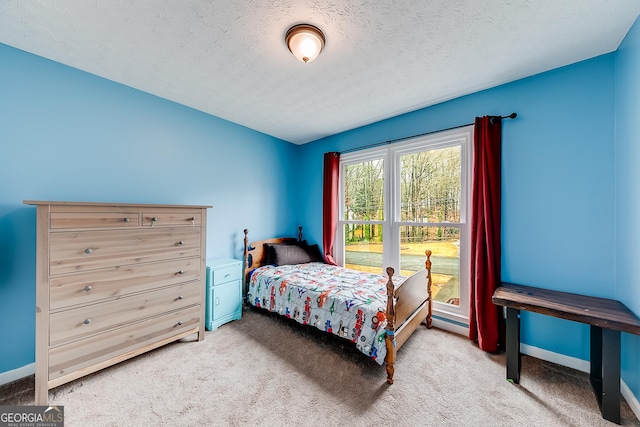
49 306 200 380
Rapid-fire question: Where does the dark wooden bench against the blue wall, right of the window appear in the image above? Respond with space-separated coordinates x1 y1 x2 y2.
493 283 640 424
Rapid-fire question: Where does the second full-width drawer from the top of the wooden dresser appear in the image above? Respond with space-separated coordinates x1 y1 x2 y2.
49 258 200 310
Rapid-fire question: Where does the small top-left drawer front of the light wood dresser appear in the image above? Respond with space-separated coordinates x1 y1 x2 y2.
50 212 140 229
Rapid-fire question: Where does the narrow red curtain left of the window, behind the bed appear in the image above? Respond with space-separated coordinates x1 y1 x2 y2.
322 152 340 265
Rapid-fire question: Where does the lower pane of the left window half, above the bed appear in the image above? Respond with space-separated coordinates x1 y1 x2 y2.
344 224 382 274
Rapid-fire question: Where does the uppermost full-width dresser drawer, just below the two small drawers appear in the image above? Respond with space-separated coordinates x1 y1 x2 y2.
49 227 200 276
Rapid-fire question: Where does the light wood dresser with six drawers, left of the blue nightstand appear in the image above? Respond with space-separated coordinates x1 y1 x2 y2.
24 200 210 405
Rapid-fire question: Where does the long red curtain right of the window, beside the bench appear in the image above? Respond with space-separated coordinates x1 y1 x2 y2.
469 116 504 352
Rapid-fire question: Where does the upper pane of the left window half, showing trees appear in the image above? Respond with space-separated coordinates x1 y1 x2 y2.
343 159 384 221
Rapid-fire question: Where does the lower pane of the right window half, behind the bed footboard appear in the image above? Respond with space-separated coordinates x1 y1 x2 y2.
400 226 460 306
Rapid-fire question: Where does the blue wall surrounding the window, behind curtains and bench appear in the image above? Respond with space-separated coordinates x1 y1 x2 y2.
300 54 624 376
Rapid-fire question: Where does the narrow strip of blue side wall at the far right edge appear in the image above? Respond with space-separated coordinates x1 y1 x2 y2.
615 20 640 402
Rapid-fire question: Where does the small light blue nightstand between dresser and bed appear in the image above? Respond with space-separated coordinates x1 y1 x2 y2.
205 258 242 331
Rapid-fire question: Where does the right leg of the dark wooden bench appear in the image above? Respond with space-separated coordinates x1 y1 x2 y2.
589 325 620 424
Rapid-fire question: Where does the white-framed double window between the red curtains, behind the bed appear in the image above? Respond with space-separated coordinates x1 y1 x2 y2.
335 126 473 324
